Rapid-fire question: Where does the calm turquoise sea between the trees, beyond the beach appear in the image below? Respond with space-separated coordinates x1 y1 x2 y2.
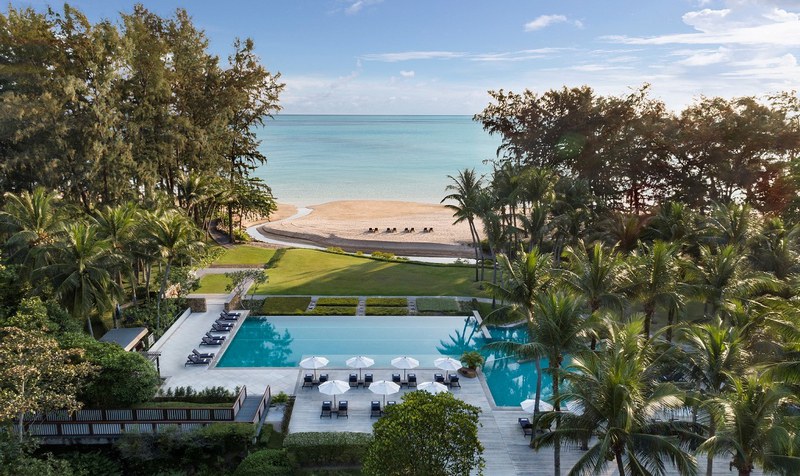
254 114 500 207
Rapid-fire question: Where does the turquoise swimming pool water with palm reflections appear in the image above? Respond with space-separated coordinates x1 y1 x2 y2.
217 316 551 406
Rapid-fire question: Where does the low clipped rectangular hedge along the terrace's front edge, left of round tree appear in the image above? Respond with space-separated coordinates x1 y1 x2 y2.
283 432 372 466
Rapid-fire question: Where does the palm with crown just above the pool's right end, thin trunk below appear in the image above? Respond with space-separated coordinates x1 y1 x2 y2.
484 248 552 413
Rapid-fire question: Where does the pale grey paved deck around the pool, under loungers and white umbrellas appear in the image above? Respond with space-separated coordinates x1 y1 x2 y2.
152 306 762 476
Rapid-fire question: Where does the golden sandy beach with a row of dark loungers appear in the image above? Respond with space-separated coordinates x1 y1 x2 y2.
259 200 472 257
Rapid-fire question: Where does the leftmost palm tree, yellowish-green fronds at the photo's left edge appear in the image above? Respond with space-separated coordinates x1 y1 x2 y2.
0 187 63 276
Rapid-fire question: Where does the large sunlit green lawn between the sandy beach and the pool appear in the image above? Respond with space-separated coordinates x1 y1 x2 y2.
196 249 483 296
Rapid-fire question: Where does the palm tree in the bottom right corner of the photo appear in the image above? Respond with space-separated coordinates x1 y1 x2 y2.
698 375 800 476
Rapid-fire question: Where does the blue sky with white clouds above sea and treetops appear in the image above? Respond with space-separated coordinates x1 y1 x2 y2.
4 0 800 115
